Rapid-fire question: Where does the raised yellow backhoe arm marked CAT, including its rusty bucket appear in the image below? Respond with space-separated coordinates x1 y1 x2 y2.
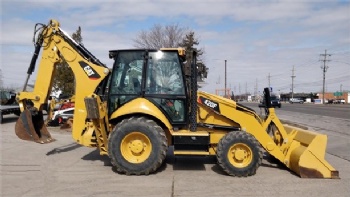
16 20 109 144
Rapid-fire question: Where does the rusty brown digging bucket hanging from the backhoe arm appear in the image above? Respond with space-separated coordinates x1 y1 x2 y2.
15 109 54 144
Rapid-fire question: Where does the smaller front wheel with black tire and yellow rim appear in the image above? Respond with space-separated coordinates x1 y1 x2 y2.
217 131 263 177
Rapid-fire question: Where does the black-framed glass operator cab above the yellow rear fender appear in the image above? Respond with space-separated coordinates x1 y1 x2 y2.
108 49 188 125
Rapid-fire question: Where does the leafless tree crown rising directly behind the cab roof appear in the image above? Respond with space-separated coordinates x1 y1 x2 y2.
133 24 187 49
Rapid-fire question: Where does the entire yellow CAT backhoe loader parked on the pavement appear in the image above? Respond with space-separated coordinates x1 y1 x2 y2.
15 20 339 178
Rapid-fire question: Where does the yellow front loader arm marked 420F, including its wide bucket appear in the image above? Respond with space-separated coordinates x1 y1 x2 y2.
198 88 339 178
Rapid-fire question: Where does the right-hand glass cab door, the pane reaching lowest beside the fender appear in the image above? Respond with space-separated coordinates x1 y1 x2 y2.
145 51 188 125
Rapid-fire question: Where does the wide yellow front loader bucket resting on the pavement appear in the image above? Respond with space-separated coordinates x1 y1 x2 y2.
284 125 339 179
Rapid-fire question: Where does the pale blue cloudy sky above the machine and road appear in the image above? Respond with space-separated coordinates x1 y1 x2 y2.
0 0 350 94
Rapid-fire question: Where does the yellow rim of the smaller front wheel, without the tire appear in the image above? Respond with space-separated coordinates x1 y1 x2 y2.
227 143 253 168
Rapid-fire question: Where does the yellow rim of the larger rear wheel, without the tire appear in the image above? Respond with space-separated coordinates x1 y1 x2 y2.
120 132 152 163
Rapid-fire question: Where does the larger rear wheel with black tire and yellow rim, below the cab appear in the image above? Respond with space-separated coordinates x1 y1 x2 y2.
108 117 168 175
